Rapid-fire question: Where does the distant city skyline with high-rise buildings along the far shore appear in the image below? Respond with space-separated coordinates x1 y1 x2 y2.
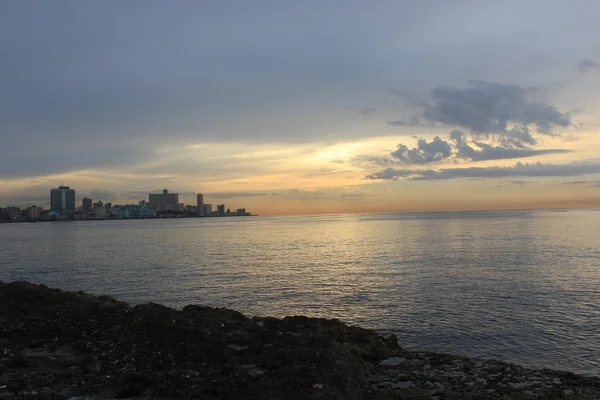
0 185 252 222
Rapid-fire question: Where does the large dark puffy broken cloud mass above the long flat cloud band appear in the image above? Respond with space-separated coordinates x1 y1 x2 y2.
380 81 572 165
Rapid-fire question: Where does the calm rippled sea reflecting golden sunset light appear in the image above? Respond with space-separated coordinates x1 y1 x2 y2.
0 210 600 376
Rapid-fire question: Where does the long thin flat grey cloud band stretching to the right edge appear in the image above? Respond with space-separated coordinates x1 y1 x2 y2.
365 162 600 181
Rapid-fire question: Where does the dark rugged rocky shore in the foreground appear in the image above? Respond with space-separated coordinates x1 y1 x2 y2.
0 282 600 400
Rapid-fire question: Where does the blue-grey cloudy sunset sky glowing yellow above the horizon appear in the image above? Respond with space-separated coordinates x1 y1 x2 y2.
0 0 600 215
